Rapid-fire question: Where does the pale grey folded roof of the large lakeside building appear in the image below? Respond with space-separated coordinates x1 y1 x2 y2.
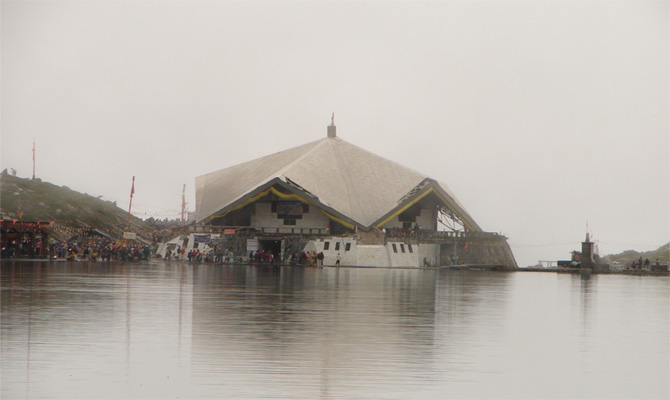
196 137 479 229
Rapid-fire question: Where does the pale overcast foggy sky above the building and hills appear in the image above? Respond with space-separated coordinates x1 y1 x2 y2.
0 0 670 266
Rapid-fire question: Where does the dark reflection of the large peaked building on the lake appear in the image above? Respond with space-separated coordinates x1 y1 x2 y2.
193 266 446 397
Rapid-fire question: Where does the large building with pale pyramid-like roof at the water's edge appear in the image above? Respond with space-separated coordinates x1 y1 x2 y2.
195 120 516 267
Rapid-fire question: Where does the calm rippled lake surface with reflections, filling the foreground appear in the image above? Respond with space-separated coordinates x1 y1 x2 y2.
0 261 670 399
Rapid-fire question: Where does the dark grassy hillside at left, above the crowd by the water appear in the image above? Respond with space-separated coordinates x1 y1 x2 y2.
0 174 150 239
